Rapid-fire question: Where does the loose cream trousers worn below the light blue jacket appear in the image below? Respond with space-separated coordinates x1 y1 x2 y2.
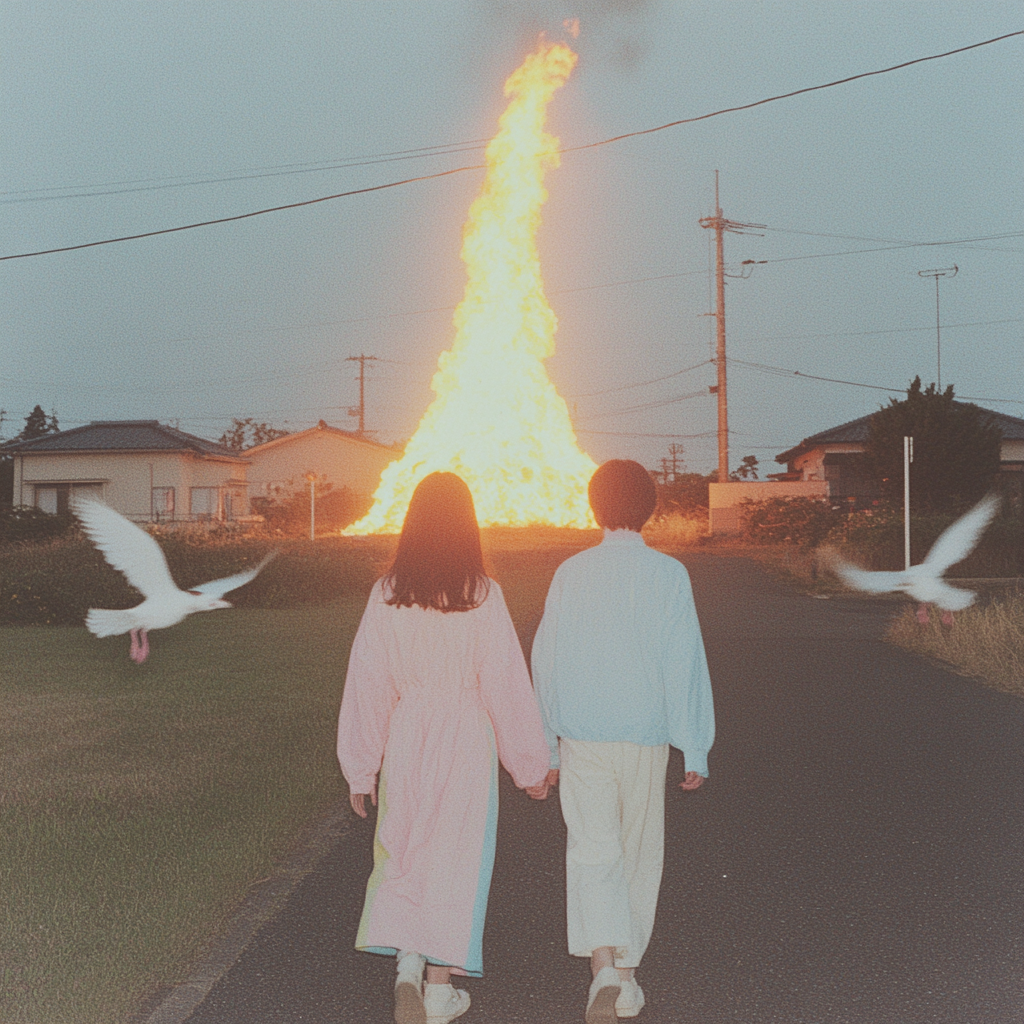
558 738 669 968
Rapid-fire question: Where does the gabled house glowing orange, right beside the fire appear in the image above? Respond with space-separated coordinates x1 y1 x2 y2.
246 420 401 498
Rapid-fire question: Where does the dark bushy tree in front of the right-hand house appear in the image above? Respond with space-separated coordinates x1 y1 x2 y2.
864 377 1002 512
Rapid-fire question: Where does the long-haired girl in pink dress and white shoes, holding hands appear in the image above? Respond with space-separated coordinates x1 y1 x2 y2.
338 473 550 1024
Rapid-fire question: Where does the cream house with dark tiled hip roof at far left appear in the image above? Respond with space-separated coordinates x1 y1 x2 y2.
0 420 249 521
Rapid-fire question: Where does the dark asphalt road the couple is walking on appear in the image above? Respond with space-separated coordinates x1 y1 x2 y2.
172 554 1024 1024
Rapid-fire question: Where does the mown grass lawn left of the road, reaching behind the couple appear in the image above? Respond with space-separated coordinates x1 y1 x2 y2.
0 530 598 1024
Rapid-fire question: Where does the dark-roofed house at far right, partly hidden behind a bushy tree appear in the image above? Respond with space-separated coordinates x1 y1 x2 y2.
768 402 1024 508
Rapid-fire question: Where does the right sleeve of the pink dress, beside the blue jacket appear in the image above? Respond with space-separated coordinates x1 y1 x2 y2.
478 582 549 788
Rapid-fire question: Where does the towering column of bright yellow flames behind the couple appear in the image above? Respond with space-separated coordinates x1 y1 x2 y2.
345 39 596 534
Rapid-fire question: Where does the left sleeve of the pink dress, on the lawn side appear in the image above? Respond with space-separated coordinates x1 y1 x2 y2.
338 583 398 793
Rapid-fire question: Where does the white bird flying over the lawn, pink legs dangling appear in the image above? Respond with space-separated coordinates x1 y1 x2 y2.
73 499 278 665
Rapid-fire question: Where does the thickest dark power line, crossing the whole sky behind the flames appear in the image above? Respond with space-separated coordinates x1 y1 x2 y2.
0 30 1024 262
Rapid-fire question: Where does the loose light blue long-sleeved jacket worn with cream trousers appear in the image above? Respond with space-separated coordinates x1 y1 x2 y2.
532 529 715 776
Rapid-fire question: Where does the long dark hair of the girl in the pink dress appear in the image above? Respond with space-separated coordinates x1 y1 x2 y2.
384 473 489 611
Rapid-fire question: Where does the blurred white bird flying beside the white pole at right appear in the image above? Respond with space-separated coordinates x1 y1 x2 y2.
835 495 999 626
